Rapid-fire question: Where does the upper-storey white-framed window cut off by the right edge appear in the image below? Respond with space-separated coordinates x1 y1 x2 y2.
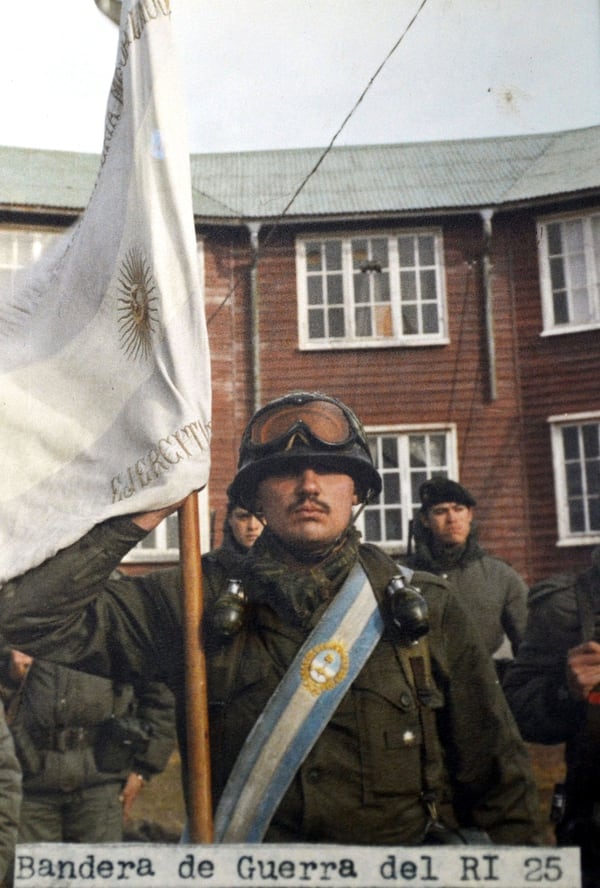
538 210 600 335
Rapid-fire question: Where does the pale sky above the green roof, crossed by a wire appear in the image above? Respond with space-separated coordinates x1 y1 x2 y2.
0 0 600 153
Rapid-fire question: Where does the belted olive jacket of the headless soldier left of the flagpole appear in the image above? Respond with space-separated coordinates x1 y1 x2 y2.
2 658 176 795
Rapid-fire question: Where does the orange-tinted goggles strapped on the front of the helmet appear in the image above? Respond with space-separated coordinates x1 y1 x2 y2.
246 399 357 453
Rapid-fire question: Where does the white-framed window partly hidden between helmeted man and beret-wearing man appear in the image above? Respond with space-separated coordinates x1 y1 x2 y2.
357 424 457 552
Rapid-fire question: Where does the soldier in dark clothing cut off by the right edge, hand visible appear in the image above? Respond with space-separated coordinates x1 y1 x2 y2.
504 548 600 888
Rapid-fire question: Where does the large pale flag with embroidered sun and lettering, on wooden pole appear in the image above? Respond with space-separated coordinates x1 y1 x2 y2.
0 0 210 582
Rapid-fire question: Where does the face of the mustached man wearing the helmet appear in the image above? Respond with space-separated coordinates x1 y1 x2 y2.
257 466 357 554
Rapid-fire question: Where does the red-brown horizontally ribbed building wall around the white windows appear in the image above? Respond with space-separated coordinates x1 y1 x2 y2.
146 210 600 582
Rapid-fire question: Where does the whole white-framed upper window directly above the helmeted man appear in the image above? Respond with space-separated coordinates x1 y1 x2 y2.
296 228 448 349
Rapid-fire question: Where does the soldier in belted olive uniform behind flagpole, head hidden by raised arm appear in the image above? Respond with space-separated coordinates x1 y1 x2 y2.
0 649 175 842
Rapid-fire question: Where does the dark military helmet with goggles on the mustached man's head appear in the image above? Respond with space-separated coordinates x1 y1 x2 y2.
228 391 381 510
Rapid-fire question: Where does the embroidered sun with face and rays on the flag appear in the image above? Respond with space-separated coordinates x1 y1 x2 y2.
118 247 159 361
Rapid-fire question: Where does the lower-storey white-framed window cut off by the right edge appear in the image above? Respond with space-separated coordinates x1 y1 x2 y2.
548 410 600 546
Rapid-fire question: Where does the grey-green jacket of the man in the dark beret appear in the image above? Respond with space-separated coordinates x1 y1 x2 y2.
404 518 527 655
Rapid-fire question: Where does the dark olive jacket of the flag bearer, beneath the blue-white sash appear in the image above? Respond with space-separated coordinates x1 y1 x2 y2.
0 519 538 844
